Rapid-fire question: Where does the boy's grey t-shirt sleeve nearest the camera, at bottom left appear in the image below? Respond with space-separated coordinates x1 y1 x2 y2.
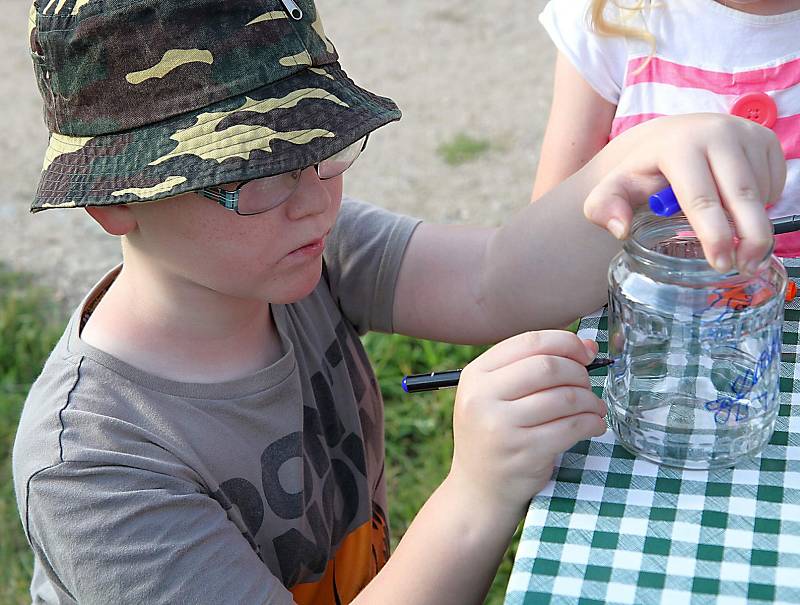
26 462 294 605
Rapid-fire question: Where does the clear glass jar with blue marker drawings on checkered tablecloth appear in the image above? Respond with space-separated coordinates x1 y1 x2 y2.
605 212 787 469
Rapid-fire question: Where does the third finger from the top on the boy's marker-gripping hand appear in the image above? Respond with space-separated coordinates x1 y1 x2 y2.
507 386 608 427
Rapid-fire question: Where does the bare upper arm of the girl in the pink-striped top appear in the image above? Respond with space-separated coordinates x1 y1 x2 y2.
531 52 616 201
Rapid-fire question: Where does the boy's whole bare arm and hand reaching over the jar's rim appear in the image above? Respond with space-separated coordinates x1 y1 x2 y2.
394 114 786 343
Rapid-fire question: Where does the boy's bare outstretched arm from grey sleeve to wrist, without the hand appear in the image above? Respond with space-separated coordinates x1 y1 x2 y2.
394 172 620 344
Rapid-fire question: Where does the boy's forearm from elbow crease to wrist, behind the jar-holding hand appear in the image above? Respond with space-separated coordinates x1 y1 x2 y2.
480 156 621 338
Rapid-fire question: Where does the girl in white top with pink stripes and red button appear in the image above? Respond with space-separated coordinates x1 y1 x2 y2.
532 0 800 257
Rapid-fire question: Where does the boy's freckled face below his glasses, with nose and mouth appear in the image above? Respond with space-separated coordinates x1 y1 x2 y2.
126 168 342 303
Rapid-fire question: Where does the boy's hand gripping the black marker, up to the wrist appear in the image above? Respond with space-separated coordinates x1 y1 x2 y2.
448 330 606 515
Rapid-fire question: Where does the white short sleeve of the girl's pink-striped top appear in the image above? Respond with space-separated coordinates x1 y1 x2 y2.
539 0 627 105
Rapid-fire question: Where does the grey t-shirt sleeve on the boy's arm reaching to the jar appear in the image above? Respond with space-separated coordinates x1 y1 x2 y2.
325 198 420 334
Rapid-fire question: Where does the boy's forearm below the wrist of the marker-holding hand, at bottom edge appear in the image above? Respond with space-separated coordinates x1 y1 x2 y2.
353 477 524 605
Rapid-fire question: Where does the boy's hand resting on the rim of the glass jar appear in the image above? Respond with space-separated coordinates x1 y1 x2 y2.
584 114 786 273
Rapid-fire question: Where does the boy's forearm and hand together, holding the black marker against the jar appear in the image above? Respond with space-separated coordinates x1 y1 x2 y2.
355 331 607 605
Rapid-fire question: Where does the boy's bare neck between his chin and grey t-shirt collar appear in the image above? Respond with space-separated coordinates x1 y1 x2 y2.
81 265 282 383
